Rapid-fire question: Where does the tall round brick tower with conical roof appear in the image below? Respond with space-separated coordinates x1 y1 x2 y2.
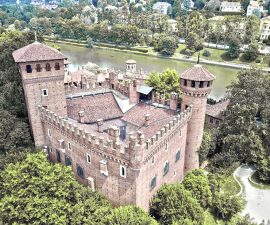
180 64 215 173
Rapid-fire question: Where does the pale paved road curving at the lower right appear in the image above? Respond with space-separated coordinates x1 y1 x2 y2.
236 166 270 222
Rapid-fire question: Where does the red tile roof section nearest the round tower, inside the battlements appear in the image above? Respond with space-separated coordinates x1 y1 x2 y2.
122 103 176 139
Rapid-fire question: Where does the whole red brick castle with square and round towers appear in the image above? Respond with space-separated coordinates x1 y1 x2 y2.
13 42 215 210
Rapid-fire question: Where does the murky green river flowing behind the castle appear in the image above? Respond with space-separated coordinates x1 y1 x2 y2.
58 44 238 100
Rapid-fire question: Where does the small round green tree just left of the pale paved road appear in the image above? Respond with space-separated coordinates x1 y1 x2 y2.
213 193 244 220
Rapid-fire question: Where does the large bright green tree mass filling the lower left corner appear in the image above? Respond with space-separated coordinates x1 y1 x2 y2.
0 152 110 224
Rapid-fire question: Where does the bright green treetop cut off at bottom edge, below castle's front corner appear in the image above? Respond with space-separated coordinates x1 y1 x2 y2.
106 206 158 225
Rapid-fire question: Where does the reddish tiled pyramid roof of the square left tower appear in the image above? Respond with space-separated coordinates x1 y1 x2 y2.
12 42 66 63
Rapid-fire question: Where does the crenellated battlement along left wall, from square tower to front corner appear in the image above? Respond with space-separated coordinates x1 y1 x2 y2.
38 106 144 164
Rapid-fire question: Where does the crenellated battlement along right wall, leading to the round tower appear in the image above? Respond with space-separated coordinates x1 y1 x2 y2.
144 105 192 161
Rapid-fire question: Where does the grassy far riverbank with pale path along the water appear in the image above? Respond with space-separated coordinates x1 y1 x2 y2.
45 37 270 71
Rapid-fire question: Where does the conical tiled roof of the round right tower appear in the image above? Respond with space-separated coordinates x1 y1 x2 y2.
180 64 215 81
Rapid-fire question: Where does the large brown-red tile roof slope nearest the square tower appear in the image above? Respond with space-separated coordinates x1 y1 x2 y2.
67 93 123 123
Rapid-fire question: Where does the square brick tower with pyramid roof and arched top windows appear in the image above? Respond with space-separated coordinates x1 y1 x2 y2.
12 42 67 146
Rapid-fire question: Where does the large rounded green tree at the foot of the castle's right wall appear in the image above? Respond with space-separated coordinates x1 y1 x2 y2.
150 184 204 225
